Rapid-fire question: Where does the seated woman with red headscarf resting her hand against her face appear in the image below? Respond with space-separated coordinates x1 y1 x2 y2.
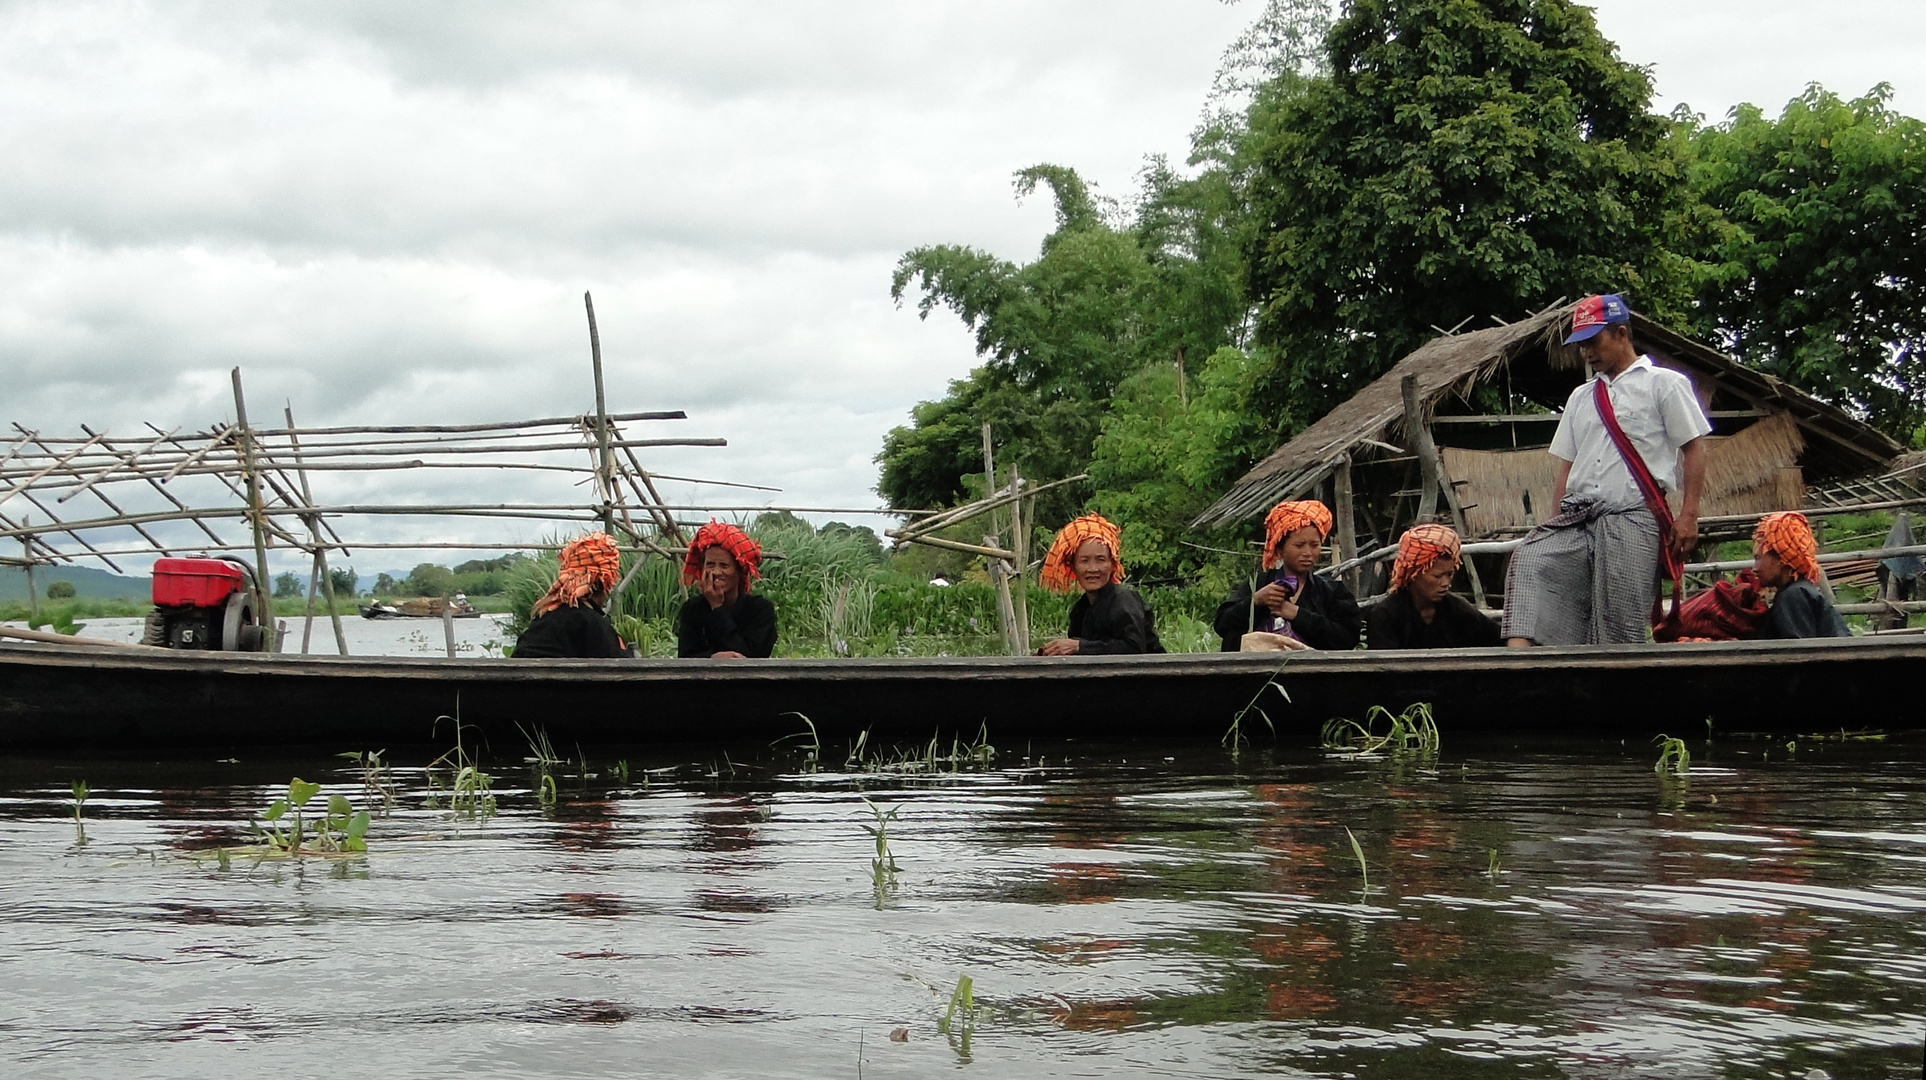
676 522 776 660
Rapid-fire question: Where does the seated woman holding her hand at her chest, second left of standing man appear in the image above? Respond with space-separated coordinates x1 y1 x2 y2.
1215 501 1364 653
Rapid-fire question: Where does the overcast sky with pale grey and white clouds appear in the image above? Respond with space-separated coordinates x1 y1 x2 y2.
0 0 1926 581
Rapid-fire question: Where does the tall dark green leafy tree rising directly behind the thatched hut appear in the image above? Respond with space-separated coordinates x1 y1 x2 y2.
1250 0 1685 435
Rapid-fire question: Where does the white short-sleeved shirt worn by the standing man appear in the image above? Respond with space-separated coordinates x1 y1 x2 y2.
1552 356 1712 502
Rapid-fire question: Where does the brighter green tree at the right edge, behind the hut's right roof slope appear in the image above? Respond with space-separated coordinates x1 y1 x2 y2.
1676 83 1926 435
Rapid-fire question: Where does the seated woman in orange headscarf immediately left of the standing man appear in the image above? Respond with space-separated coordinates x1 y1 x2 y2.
1364 526 1504 649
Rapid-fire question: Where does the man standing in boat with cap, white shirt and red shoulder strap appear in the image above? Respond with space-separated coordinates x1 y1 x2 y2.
1504 295 1712 645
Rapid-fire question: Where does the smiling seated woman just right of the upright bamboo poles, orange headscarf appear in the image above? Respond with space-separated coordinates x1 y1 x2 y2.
1036 514 1163 656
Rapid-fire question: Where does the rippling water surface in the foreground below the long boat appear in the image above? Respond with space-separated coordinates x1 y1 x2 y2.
0 741 1926 1076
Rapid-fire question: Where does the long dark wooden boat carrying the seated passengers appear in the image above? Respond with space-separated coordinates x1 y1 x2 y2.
0 635 1926 755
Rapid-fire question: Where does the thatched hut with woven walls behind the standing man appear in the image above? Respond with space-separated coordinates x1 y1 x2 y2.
1196 304 1905 541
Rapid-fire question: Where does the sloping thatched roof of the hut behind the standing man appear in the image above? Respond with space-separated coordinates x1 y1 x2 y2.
1192 304 1905 527
